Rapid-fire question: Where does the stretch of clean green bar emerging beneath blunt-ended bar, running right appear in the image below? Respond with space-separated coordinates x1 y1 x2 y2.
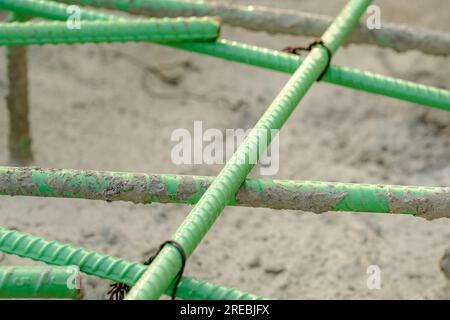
168 40 450 111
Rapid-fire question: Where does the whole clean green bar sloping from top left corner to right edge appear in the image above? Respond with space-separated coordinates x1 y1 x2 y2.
0 0 450 111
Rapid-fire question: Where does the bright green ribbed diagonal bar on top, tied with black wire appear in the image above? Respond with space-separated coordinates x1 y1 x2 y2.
126 0 371 300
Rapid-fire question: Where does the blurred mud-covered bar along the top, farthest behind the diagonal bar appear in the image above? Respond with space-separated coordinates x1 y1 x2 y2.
56 0 450 56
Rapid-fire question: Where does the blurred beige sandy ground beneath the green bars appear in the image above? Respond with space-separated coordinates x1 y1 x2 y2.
0 0 450 299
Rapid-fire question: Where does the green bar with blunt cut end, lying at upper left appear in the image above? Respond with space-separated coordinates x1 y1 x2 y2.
0 18 219 46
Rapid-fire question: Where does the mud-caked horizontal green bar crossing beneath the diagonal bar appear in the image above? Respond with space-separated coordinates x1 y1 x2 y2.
0 167 450 219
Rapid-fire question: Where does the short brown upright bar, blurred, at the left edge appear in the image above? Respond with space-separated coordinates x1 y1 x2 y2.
6 12 33 165
